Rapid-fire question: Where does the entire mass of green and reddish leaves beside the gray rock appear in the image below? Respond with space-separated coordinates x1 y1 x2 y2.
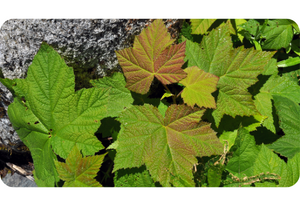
0 19 300 187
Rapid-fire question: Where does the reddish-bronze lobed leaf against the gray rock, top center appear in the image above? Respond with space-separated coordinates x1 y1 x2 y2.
116 20 186 94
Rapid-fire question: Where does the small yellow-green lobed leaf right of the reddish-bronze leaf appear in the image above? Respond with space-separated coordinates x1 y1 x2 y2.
179 66 219 108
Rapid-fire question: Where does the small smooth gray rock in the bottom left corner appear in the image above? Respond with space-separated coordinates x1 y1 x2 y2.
2 173 37 187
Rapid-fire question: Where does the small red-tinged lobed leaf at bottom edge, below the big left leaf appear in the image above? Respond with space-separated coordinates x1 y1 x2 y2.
55 146 106 187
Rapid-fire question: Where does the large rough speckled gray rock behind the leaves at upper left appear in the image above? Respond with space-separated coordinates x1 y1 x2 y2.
0 19 180 145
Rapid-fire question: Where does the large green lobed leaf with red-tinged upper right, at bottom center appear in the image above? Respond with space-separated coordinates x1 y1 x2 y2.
114 104 223 186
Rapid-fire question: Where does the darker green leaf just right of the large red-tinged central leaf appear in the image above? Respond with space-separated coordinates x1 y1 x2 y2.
226 128 259 179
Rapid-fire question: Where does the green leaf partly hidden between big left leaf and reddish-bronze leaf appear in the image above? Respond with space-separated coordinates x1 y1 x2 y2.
90 73 133 117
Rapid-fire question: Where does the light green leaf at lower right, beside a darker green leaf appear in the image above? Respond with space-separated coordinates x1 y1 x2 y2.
253 144 288 186
